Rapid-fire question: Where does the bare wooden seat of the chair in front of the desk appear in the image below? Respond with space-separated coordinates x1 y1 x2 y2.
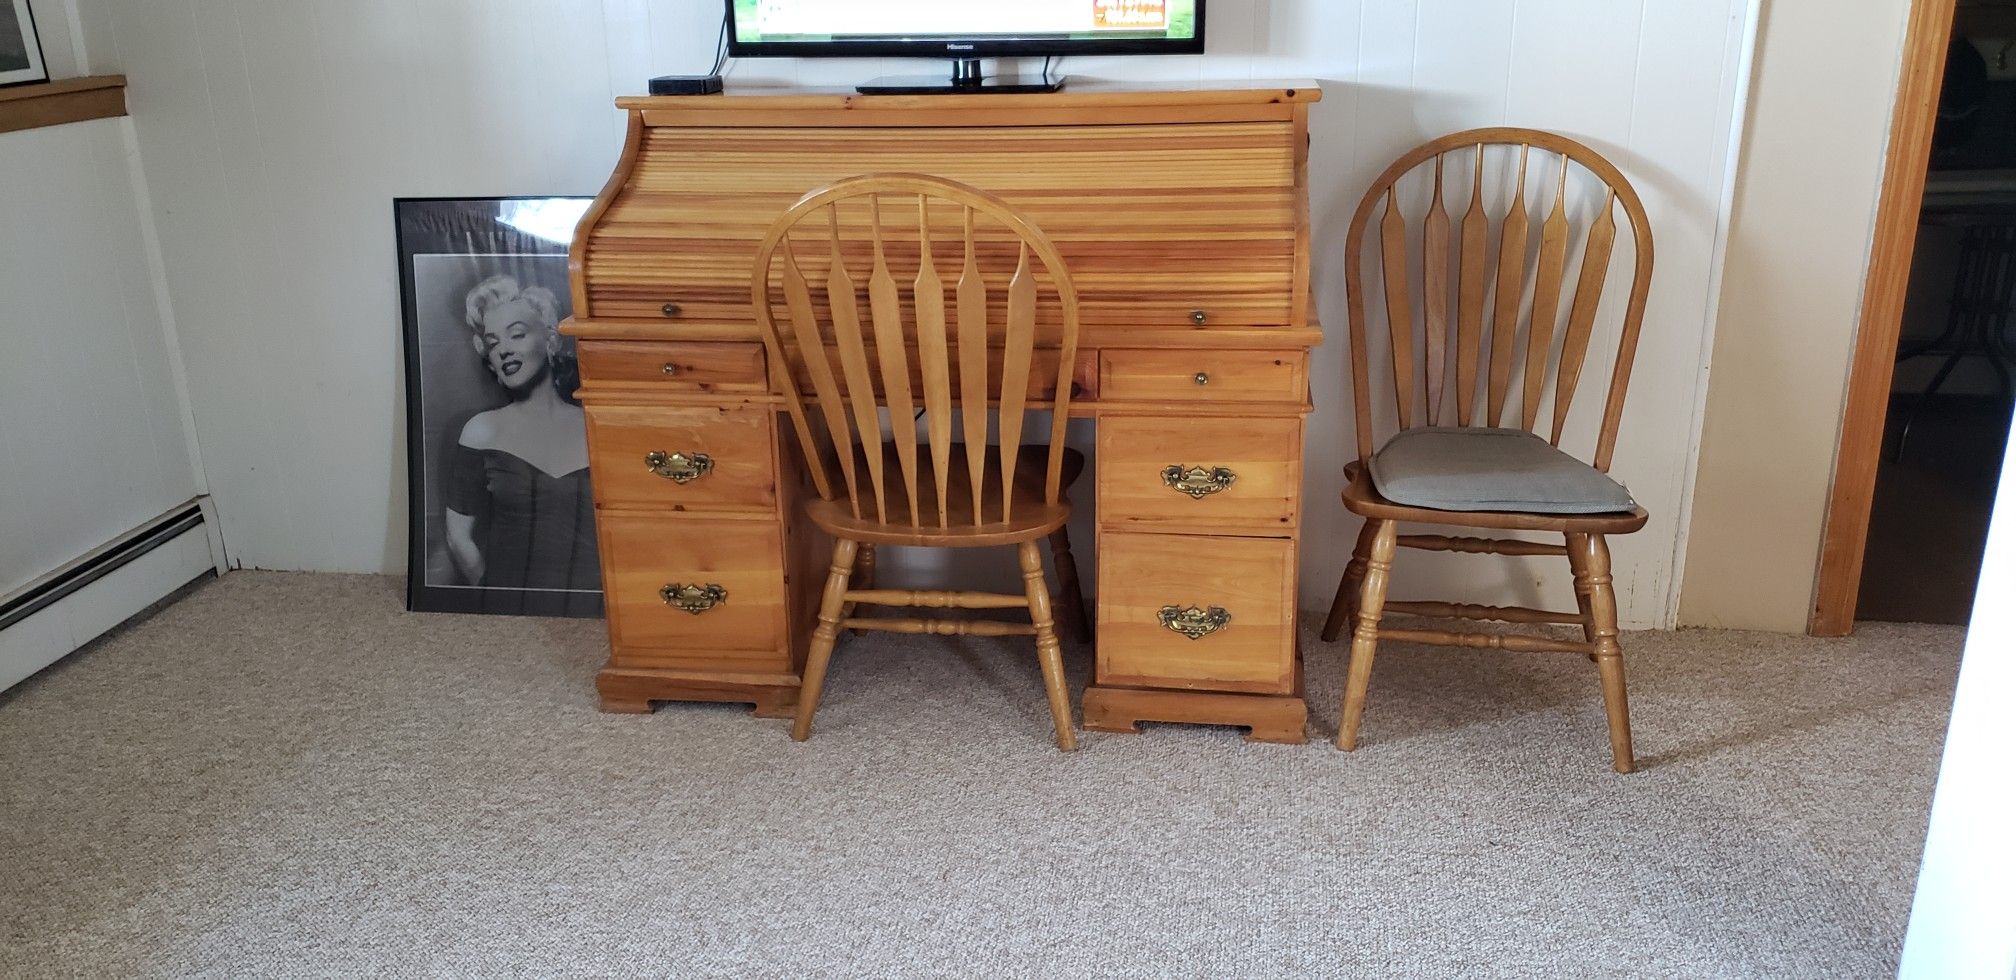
804 444 1085 548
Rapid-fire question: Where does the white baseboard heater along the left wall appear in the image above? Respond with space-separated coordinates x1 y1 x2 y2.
0 502 216 690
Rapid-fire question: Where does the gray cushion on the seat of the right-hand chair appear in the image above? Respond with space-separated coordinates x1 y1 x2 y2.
1371 425 1633 514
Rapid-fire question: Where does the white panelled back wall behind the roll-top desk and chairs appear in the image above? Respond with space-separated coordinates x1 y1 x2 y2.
79 0 1746 625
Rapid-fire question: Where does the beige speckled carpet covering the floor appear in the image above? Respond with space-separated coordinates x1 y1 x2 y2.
0 573 1962 978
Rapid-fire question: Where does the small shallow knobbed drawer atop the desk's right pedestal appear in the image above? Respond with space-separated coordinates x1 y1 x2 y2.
1099 349 1308 401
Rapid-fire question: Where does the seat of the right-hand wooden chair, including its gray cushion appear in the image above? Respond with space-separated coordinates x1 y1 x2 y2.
1343 427 1647 534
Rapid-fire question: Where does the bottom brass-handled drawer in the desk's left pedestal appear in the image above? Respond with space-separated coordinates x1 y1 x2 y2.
595 512 790 657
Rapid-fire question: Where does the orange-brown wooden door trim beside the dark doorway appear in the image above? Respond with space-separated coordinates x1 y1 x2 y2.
1806 0 1956 637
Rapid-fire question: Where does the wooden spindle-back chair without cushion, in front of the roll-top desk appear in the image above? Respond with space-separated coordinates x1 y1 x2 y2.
754 173 1087 750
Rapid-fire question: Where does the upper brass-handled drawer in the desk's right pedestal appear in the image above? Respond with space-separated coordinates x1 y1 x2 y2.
1099 415 1302 534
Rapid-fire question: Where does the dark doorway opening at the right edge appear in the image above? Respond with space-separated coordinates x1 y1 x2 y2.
1855 21 2016 623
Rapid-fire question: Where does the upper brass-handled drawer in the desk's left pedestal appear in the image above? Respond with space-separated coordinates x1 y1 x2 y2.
587 405 776 510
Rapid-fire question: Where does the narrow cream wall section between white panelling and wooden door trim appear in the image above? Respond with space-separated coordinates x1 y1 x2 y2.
1679 0 1911 633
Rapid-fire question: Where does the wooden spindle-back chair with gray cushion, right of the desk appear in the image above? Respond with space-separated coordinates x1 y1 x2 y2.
1322 129 1653 772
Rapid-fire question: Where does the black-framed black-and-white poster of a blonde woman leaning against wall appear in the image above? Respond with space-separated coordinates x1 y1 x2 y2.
393 195 603 617
